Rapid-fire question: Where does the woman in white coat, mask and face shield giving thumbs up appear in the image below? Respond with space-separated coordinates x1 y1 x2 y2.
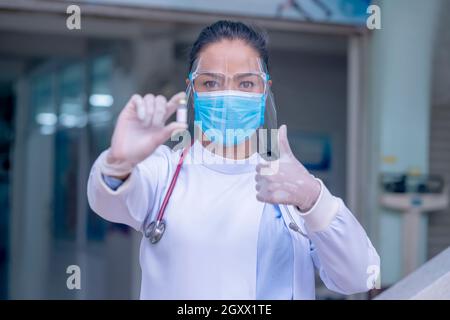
88 21 380 299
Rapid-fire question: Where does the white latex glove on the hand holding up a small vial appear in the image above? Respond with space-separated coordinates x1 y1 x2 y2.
101 92 187 178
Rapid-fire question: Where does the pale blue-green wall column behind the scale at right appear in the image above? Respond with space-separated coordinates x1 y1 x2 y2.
369 0 440 284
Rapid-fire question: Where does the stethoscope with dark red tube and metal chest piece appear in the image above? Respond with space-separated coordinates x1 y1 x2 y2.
144 144 192 244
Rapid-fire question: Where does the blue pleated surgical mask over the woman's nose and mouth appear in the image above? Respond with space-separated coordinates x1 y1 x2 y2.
194 90 266 146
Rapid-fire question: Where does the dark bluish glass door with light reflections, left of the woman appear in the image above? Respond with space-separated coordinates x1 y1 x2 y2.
10 55 118 299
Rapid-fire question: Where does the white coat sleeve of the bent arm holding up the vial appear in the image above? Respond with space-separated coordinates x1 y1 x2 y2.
87 145 173 231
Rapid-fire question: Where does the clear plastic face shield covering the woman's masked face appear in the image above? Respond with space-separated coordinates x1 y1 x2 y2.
186 57 277 159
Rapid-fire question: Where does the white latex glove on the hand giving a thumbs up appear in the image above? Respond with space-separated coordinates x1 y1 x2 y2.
255 125 321 212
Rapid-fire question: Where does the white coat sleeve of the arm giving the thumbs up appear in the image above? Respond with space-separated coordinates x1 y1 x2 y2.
299 184 380 295
